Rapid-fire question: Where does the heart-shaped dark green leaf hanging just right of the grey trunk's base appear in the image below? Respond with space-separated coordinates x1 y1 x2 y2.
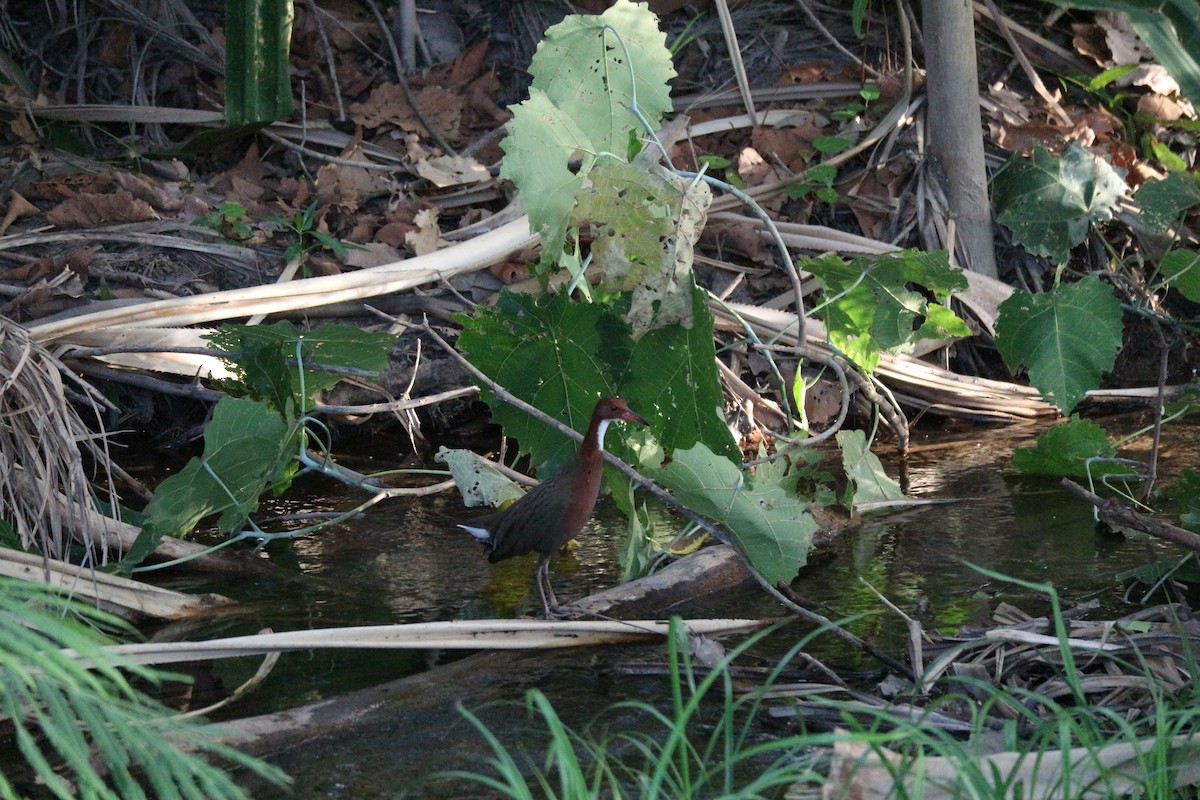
996 272 1121 414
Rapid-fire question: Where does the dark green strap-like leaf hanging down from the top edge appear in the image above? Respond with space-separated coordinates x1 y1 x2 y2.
224 0 294 127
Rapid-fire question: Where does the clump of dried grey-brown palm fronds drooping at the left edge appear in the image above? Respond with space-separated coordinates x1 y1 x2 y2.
0 317 115 564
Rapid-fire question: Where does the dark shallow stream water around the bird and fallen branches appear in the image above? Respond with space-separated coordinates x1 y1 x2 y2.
152 417 1200 798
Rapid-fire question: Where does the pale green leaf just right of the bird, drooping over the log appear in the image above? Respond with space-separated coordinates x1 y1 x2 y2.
654 445 817 584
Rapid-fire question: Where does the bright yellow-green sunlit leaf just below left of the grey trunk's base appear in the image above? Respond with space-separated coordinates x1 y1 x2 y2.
800 249 971 371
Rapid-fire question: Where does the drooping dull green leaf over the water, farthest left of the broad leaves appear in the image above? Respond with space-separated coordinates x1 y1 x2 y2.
142 397 295 537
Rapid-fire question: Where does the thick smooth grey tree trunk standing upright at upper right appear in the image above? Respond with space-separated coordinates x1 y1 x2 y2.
922 0 996 277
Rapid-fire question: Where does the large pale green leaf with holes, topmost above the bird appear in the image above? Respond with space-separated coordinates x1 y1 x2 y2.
500 0 674 271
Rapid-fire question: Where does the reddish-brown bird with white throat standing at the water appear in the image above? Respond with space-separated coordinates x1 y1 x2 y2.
458 397 649 616
